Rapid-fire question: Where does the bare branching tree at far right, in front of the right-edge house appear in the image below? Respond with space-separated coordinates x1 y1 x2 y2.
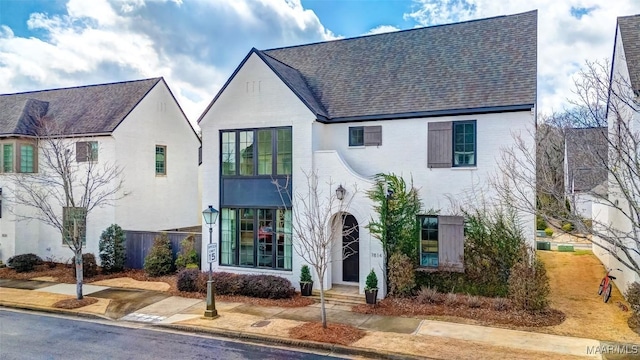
493 62 640 275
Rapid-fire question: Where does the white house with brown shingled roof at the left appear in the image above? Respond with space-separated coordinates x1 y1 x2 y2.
0 78 201 261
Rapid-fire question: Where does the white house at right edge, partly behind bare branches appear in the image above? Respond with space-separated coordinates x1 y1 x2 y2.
593 15 640 292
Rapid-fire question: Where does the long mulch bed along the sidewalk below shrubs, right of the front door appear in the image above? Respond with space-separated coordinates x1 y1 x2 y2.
352 298 565 327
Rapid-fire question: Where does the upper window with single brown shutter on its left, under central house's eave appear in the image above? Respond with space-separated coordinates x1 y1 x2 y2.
427 120 477 168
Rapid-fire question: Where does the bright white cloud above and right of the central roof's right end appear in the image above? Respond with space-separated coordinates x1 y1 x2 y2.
405 0 640 112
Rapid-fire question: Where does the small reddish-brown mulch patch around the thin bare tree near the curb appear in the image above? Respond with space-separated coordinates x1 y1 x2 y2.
289 322 365 346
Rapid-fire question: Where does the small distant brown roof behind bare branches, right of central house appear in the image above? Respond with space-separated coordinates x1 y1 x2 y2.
566 127 608 191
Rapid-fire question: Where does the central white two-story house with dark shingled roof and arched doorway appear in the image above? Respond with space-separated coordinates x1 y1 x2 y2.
199 11 537 296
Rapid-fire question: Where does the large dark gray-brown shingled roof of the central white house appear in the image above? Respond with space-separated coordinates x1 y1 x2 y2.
250 11 537 122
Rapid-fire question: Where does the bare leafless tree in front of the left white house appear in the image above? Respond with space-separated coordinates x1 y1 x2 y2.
11 116 127 300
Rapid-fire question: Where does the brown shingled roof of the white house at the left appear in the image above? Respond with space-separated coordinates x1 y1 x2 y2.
0 78 162 136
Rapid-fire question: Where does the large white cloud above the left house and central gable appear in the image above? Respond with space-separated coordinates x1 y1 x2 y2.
0 0 334 121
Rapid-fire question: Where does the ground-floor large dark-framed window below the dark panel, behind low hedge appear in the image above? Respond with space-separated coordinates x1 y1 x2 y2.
220 208 292 270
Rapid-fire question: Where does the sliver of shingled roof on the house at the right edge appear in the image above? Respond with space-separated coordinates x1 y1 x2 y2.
618 15 640 95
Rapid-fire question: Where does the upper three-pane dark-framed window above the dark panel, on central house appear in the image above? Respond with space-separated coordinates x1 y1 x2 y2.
220 127 293 176
